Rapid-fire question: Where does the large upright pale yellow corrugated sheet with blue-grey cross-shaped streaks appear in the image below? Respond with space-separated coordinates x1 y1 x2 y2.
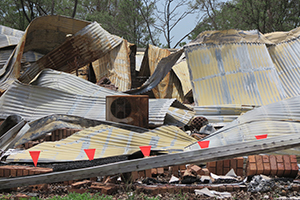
184 43 286 106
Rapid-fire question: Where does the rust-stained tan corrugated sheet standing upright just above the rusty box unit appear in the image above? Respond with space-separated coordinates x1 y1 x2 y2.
93 39 131 91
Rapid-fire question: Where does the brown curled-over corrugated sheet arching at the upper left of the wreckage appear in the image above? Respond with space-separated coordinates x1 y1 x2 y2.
0 16 90 92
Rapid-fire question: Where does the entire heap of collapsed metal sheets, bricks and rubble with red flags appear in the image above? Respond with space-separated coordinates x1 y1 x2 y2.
0 16 300 198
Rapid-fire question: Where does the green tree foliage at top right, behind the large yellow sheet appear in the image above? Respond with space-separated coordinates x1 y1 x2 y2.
189 0 300 39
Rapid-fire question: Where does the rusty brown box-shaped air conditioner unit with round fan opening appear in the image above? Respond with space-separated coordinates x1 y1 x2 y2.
106 95 149 128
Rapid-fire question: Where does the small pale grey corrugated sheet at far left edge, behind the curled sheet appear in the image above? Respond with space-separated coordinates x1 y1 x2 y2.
0 25 24 48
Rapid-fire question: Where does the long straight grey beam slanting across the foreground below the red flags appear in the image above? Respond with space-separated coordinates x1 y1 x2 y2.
0 134 300 189
